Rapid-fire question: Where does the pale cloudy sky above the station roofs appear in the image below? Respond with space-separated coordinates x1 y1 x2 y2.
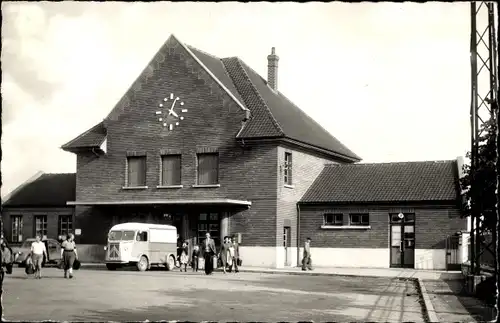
1 1 480 196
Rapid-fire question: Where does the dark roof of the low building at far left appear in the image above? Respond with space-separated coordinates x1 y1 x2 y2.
2 173 76 207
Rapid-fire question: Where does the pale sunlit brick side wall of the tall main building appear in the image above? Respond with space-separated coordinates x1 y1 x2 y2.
276 145 334 247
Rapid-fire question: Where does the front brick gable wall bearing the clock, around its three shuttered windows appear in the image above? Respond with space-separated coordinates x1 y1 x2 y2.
76 37 277 246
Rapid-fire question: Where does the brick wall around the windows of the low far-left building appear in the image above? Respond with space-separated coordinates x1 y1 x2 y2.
2 207 75 246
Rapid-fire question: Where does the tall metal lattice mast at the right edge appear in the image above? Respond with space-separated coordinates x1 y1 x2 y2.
470 1 500 281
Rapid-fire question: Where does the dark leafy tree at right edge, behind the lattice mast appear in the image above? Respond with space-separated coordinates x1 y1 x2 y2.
460 111 498 232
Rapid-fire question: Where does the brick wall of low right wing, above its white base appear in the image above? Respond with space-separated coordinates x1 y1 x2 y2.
300 205 466 249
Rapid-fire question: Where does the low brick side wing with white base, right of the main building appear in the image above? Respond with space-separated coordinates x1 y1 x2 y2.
297 160 467 270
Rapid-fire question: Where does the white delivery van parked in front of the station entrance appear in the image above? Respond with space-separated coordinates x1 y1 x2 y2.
104 222 177 271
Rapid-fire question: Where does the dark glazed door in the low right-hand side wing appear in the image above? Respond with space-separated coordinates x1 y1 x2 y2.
390 213 415 268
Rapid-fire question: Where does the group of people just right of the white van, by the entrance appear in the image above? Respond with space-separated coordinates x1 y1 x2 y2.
177 232 241 275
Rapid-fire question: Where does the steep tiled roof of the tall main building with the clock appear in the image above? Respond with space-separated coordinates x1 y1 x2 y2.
62 35 361 162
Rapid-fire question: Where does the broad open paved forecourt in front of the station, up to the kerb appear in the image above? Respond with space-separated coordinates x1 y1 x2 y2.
3 268 423 322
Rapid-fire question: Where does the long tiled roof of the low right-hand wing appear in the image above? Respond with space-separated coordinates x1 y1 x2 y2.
301 160 459 203
